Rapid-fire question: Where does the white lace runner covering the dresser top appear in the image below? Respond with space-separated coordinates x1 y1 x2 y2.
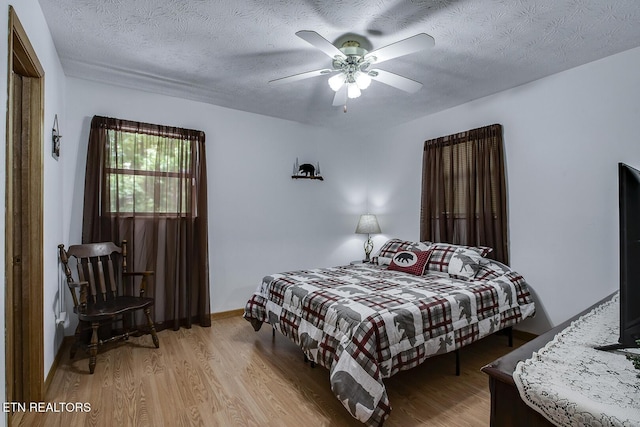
513 294 640 426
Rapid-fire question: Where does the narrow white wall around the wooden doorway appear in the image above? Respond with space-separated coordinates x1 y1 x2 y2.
0 0 65 424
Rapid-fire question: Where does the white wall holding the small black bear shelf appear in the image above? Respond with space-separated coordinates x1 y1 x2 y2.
62 78 366 318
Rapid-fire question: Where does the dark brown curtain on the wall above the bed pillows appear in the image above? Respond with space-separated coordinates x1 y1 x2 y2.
420 124 509 264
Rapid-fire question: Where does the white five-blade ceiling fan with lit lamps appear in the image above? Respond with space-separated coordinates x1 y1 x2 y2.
269 31 435 113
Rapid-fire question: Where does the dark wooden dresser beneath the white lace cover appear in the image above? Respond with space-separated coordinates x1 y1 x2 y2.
482 293 615 427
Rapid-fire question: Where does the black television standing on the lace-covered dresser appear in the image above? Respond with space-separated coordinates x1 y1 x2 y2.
598 163 640 350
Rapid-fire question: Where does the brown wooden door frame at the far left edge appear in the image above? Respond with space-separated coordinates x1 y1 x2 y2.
5 6 44 412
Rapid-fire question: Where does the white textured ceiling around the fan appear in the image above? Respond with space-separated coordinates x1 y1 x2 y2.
40 0 640 129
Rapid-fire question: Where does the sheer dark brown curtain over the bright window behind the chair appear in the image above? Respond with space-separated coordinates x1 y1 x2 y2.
82 116 211 329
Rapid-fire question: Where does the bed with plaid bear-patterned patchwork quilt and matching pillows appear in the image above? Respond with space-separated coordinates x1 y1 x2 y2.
244 239 535 426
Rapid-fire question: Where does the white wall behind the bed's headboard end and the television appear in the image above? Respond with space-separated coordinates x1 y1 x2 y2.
362 48 640 333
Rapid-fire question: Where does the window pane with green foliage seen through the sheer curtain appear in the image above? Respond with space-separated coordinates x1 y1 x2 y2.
106 130 192 214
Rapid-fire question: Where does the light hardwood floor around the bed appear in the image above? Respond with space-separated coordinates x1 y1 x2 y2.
19 316 525 427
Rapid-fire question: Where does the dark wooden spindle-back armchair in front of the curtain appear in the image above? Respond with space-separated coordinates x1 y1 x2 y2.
58 240 160 374
